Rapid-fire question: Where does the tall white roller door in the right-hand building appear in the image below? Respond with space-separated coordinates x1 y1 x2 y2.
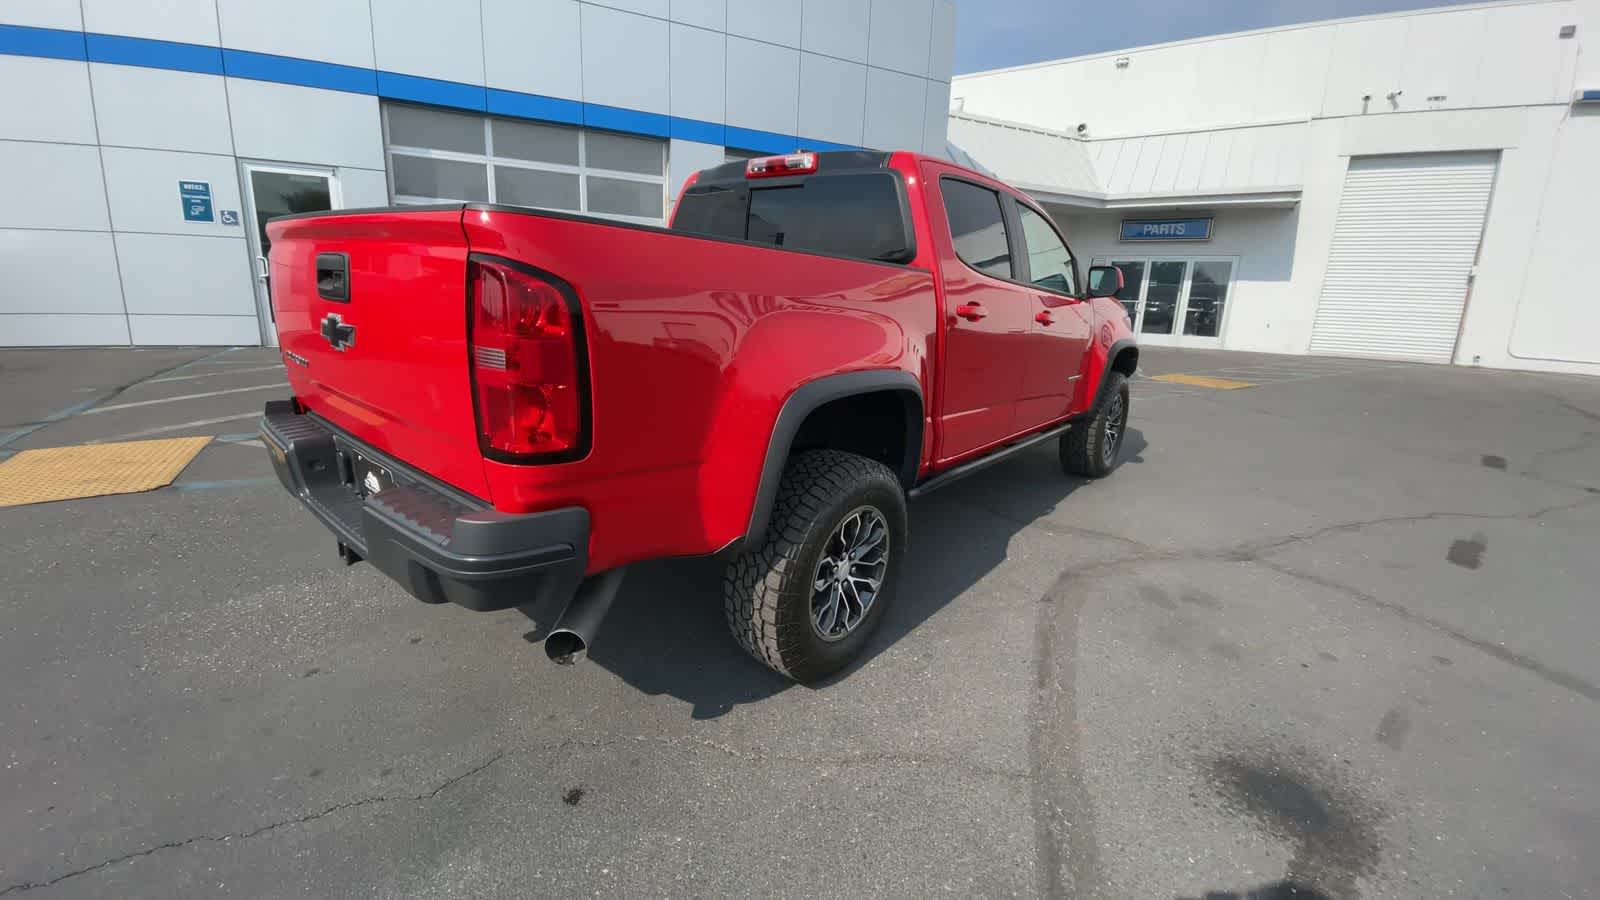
1310 152 1499 362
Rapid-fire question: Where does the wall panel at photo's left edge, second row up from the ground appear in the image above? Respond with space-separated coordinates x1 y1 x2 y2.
0 227 123 315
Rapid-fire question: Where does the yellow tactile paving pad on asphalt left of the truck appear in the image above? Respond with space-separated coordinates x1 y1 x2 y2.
0 436 211 506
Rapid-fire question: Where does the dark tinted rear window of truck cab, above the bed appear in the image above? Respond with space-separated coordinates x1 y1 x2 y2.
672 171 914 263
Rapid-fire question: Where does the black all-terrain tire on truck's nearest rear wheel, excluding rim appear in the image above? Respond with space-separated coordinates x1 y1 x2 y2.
722 450 906 682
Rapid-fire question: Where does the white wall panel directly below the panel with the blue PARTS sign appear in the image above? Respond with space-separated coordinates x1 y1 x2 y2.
117 234 256 315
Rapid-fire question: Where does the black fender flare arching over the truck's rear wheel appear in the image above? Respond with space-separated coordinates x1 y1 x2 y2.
744 368 923 548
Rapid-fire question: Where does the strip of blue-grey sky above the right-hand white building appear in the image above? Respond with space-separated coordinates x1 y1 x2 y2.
955 0 1467 75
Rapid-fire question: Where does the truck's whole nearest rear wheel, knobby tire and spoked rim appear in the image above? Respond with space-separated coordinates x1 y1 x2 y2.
723 450 906 682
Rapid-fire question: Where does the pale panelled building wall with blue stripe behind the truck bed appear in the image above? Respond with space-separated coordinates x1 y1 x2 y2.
0 0 955 346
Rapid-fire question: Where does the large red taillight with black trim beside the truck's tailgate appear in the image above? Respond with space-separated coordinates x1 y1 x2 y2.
467 256 589 461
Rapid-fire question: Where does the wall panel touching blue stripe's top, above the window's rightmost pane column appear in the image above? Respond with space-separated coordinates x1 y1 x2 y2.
579 3 670 115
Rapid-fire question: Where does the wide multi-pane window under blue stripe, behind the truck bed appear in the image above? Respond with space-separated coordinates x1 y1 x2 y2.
384 102 667 224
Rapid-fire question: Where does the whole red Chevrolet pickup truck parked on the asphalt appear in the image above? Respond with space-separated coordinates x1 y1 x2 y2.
261 151 1139 681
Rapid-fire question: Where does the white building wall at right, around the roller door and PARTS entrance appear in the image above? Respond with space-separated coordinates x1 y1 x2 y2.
952 0 1600 375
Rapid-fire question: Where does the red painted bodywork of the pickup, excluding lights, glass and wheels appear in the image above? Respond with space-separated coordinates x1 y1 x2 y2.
267 154 1130 572
